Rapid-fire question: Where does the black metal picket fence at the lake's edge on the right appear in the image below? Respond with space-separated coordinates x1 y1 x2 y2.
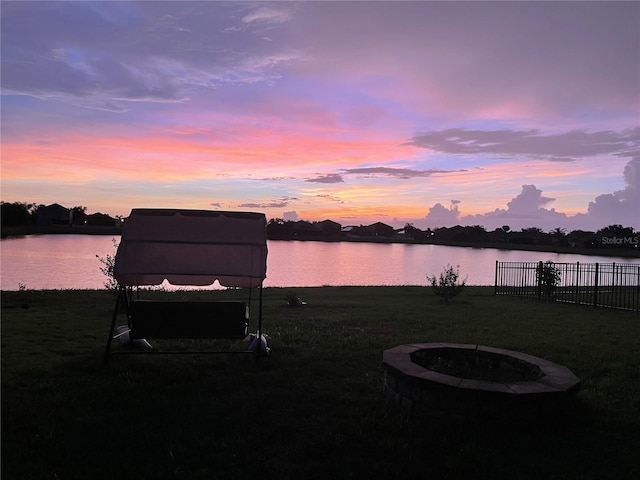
495 262 640 312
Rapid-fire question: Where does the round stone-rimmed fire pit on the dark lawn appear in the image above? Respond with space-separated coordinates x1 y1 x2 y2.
383 343 580 421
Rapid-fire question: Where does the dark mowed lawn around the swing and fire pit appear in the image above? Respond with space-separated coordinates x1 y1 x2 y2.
2 287 640 480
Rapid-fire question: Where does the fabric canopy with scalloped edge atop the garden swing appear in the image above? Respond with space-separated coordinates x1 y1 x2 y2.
113 209 267 288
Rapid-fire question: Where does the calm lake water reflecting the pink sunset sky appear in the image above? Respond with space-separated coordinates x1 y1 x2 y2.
0 235 640 290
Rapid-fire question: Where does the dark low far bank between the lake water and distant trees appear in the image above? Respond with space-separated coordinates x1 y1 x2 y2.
1 225 640 258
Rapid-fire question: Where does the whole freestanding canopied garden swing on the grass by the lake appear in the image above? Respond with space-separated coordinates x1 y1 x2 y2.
104 209 267 365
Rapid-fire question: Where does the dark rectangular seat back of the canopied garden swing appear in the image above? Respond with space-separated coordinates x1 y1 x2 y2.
130 300 249 339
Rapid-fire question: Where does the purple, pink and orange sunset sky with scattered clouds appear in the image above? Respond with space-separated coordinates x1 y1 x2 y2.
0 1 640 231
